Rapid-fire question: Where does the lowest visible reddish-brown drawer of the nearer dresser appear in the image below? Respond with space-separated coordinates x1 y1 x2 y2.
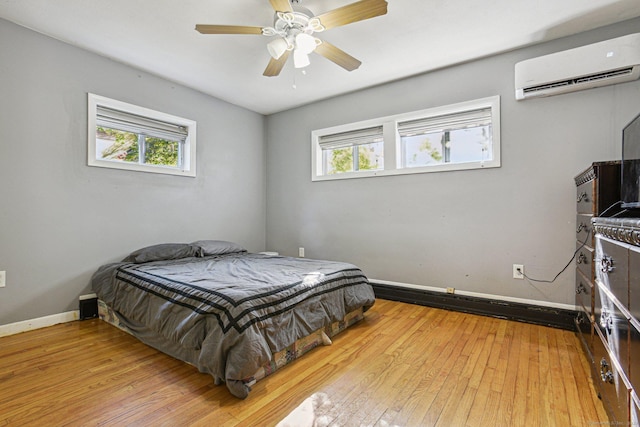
593 333 630 424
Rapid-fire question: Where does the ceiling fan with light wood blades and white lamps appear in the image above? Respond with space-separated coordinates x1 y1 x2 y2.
196 0 387 77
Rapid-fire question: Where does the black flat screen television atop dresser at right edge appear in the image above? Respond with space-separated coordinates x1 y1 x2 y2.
620 114 640 209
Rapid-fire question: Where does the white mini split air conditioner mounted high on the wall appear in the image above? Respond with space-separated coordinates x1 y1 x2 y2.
515 33 640 100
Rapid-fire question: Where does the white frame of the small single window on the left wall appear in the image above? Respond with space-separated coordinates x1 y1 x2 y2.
87 93 196 177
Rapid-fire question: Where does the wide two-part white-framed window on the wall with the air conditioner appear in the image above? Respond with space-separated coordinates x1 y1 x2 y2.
311 96 500 181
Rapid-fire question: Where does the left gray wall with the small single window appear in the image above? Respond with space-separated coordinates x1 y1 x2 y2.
0 20 266 325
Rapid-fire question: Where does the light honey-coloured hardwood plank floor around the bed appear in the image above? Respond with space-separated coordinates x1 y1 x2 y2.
0 300 608 427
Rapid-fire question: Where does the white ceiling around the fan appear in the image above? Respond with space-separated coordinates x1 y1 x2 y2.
0 0 640 114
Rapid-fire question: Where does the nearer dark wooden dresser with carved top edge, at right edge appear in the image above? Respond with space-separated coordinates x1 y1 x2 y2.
591 218 640 426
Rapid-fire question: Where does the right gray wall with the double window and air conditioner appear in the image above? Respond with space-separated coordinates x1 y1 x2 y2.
266 19 640 305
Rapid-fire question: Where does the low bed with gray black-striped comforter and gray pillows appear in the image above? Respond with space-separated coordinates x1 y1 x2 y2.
91 240 375 399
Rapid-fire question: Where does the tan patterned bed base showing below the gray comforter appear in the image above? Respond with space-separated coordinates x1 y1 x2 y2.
98 300 364 387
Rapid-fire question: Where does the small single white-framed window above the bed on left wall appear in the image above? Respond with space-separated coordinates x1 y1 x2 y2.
88 94 196 176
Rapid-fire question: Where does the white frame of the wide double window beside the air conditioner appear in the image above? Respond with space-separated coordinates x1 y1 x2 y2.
311 95 500 181
